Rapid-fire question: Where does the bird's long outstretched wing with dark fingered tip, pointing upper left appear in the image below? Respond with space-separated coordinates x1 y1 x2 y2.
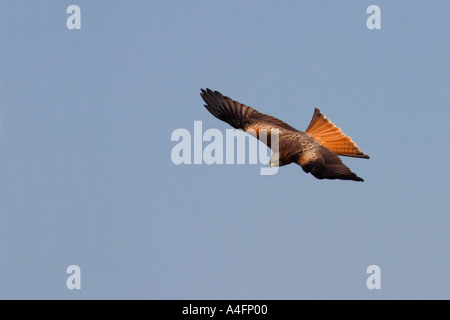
200 89 298 134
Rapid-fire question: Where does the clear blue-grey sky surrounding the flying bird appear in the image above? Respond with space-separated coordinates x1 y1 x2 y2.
0 0 450 299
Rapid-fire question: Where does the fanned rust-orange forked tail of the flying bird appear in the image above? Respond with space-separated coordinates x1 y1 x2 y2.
306 108 369 159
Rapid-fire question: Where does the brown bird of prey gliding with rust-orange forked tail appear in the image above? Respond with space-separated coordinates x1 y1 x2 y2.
200 89 369 181
